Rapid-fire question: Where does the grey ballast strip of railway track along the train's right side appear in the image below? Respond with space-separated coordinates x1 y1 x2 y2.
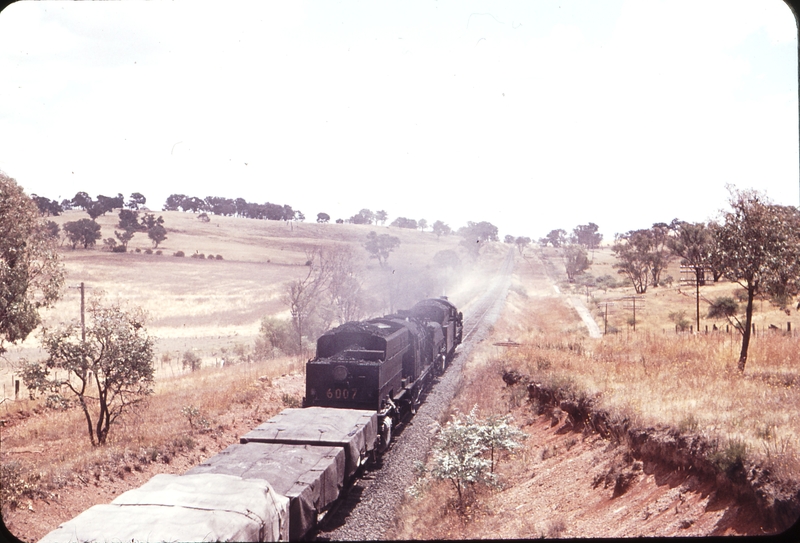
316 249 514 541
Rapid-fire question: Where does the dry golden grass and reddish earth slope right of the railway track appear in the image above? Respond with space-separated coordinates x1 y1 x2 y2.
391 248 800 539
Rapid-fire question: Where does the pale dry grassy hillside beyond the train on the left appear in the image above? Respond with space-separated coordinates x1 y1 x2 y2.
0 211 476 382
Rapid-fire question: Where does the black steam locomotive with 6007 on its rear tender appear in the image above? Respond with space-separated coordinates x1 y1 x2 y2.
303 298 463 449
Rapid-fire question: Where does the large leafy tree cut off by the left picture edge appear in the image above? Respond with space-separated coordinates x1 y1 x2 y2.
0 172 64 353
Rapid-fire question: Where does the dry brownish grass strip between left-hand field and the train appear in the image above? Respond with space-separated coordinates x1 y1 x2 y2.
2 358 302 505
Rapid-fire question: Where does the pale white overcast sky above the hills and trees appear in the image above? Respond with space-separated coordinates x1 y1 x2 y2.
0 0 800 240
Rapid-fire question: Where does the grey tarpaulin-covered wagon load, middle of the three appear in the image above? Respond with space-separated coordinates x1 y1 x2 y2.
186 443 345 541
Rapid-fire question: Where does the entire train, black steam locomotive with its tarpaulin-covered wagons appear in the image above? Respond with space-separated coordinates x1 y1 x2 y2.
41 297 462 543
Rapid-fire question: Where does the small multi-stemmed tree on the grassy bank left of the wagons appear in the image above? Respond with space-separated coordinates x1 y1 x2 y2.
22 300 154 446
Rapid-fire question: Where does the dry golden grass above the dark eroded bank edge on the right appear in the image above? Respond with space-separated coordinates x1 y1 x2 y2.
524 248 800 478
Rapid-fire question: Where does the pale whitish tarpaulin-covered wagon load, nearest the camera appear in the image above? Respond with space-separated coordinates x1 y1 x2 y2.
40 473 289 543
